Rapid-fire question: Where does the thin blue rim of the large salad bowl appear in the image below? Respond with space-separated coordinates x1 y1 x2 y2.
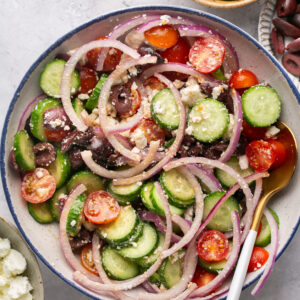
0 5 300 300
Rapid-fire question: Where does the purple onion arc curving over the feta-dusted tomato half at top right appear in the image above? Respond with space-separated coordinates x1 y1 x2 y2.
178 25 239 74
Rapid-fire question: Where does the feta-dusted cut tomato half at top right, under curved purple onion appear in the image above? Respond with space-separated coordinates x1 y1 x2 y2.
189 36 225 73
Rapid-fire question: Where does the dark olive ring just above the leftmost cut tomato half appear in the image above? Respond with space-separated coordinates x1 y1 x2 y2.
32 142 56 167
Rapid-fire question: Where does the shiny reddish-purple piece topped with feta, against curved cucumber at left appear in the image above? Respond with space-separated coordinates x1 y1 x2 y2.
43 107 71 131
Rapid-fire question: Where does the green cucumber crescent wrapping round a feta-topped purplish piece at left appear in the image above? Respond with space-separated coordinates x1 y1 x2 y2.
30 98 61 142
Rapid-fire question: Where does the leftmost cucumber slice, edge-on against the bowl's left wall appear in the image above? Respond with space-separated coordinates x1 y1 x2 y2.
14 129 35 172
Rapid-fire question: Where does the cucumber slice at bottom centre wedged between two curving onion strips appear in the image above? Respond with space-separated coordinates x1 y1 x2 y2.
158 251 185 289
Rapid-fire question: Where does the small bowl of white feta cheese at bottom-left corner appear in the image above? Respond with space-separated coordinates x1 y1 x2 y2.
0 217 44 300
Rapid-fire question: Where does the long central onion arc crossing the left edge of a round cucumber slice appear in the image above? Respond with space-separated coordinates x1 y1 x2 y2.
114 74 186 185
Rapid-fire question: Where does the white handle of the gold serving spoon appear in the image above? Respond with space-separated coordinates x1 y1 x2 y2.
227 230 257 300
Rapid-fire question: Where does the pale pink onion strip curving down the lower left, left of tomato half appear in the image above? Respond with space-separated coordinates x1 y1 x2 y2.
59 184 99 281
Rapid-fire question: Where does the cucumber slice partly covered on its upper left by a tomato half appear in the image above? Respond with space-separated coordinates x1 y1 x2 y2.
98 205 140 243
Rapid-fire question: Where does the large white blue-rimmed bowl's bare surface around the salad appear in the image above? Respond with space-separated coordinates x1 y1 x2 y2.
1 6 300 299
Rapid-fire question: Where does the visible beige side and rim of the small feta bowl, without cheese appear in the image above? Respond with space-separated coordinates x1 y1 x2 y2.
0 218 44 300
